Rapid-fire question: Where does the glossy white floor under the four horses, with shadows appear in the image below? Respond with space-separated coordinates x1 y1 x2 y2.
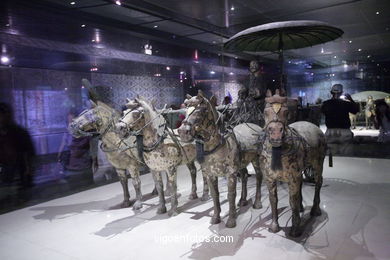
0 157 390 260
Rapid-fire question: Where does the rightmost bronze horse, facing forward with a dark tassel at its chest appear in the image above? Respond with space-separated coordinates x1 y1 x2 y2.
260 90 326 237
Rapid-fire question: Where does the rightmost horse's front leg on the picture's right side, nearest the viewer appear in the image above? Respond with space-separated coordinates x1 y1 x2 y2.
288 178 302 237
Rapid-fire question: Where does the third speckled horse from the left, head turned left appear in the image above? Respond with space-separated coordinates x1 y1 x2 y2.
178 91 262 228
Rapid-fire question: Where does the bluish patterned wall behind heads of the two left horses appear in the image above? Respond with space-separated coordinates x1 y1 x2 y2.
91 74 184 109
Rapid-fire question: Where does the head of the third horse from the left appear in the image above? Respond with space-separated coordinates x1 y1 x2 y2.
178 90 218 142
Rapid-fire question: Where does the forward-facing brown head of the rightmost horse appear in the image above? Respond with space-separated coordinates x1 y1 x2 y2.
264 89 288 147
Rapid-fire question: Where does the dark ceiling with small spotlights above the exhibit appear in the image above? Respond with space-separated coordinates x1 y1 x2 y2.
0 0 390 65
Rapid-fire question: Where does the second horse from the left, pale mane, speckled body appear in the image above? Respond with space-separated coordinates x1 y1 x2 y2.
116 98 208 215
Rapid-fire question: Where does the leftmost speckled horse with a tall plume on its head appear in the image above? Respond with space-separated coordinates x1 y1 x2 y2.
69 80 142 209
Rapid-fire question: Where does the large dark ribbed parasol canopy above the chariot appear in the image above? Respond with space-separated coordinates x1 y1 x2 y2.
224 21 344 52
